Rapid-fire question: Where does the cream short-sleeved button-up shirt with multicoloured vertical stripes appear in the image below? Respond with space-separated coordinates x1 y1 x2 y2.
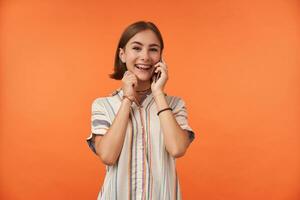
87 88 194 200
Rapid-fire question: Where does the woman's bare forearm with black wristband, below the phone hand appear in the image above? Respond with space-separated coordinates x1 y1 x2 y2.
154 93 191 158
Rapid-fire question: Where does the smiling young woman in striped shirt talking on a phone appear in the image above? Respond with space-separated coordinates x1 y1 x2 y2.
87 21 194 200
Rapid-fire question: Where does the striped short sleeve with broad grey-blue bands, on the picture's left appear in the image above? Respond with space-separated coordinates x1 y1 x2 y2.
86 98 111 153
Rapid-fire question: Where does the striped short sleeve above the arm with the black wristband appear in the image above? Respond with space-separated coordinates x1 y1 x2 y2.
173 97 195 141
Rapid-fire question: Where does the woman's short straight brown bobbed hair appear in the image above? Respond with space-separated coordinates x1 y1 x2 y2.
109 21 164 80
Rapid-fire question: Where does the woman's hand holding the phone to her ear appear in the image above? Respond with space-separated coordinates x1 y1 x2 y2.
151 59 168 95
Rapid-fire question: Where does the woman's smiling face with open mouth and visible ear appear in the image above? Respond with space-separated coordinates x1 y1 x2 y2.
119 30 161 82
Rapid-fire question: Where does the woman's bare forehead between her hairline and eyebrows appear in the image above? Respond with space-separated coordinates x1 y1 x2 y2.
127 30 161 46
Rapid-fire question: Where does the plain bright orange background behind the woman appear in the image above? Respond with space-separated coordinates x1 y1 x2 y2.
0 0 300 200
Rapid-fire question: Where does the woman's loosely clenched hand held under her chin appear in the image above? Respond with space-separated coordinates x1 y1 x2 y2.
122 70 137 98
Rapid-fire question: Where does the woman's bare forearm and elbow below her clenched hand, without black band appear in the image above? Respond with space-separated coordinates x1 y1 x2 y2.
95 98 131 165
